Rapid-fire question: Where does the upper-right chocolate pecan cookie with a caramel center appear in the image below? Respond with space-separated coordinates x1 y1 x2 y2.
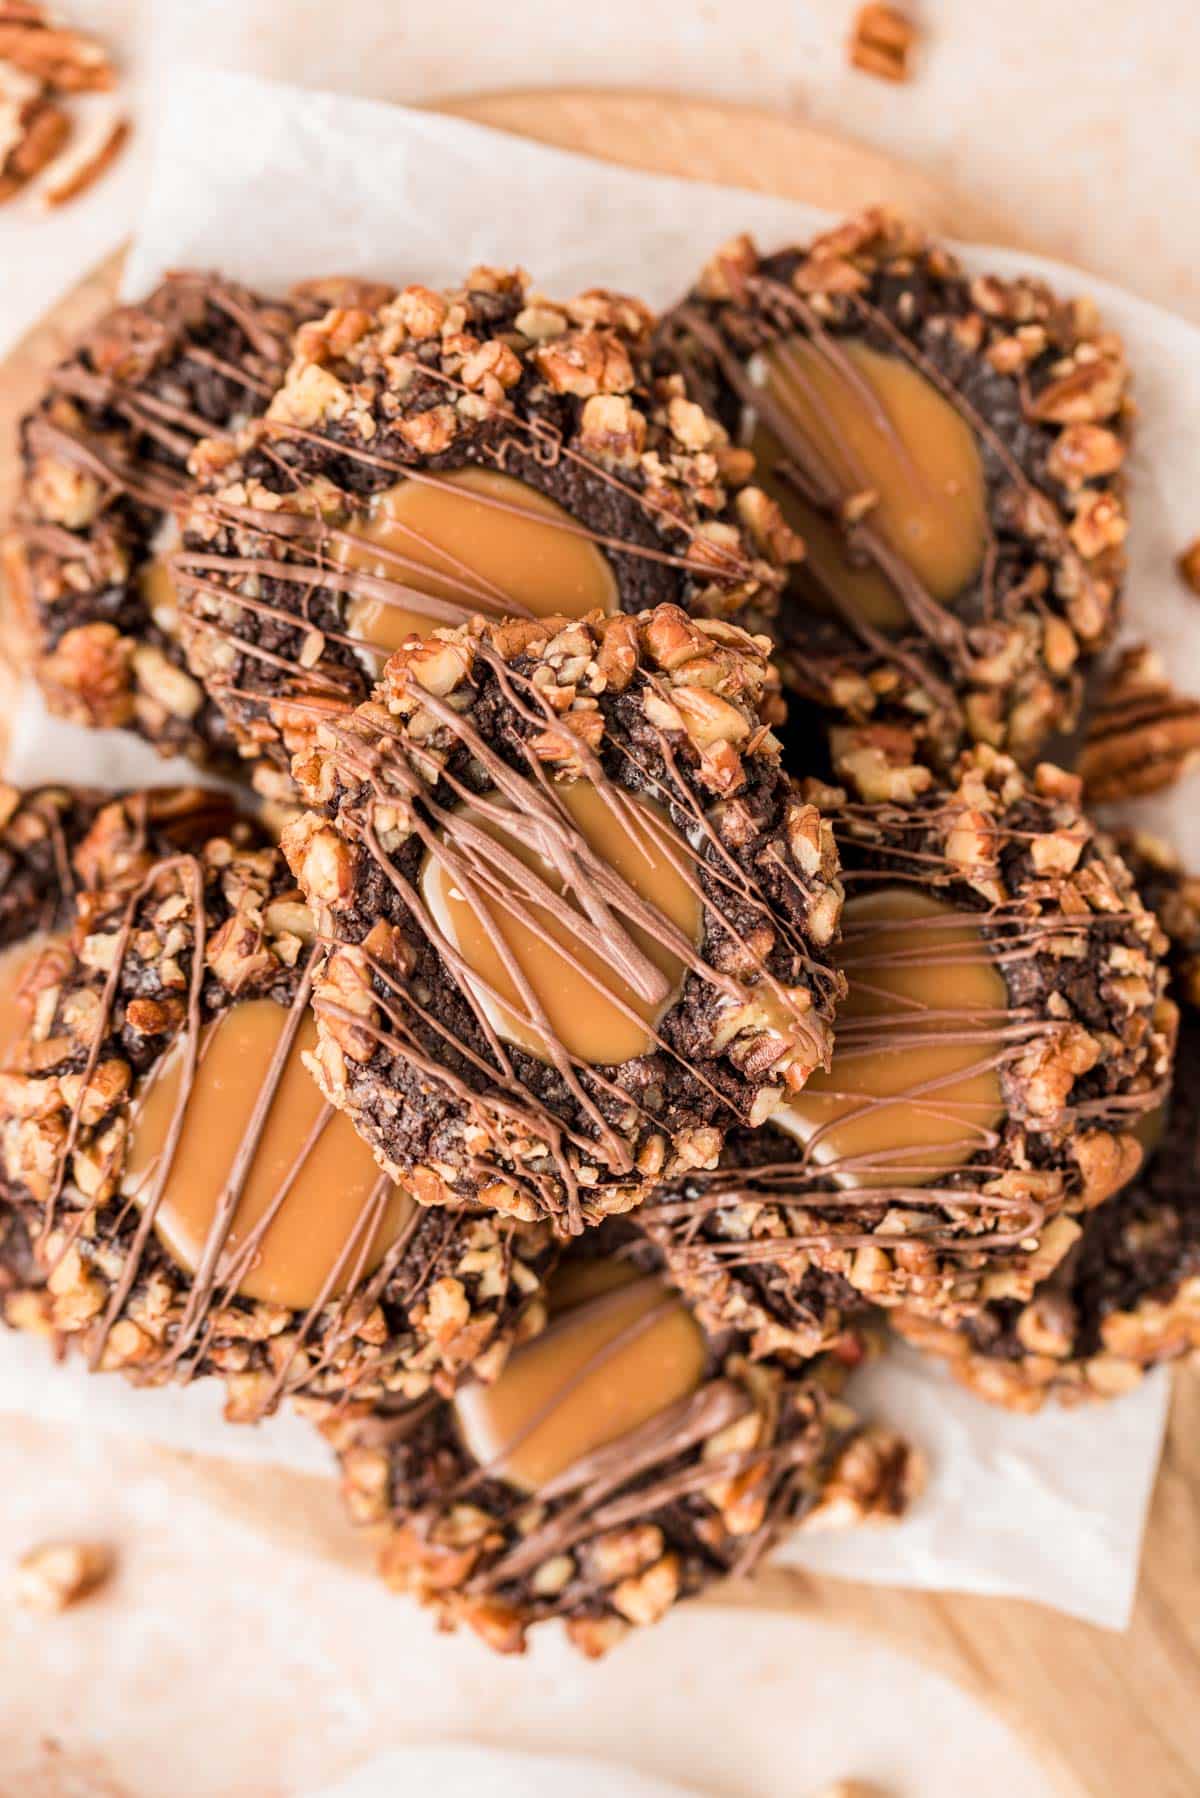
658 209 1132 768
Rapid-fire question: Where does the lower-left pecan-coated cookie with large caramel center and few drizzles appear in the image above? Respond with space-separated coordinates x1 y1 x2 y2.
0 838 552 1419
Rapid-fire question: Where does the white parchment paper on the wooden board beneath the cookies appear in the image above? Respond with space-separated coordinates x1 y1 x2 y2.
9 68 1200 1627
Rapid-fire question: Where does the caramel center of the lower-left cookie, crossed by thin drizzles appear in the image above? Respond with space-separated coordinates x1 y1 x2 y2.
126 1000 412 1311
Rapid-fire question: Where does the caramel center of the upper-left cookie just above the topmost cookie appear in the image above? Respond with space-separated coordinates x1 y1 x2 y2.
335 467 617 654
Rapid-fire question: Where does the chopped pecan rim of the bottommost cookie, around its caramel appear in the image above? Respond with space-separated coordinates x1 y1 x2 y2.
314 1241 906 1658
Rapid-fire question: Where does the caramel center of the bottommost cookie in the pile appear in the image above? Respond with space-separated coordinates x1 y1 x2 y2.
453 1262 707 1492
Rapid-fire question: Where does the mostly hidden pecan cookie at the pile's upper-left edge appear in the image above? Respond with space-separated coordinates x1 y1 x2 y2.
5 273 336 761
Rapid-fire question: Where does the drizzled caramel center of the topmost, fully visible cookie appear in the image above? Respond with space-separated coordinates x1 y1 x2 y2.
421 780 702 1066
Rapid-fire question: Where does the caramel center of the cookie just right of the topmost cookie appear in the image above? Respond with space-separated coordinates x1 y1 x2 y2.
774 886 1009 1187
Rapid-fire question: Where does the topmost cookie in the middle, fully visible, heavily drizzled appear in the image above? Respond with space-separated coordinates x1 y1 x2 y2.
284 606 842 1233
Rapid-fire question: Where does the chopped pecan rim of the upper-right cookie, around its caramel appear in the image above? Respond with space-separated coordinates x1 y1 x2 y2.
658 209 1132 768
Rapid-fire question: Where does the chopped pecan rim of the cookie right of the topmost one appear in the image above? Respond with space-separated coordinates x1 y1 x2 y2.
642 748 1177 1323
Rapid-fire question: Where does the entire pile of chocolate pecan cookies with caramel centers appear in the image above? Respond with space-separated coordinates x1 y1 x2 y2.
0 214 1200 1654
